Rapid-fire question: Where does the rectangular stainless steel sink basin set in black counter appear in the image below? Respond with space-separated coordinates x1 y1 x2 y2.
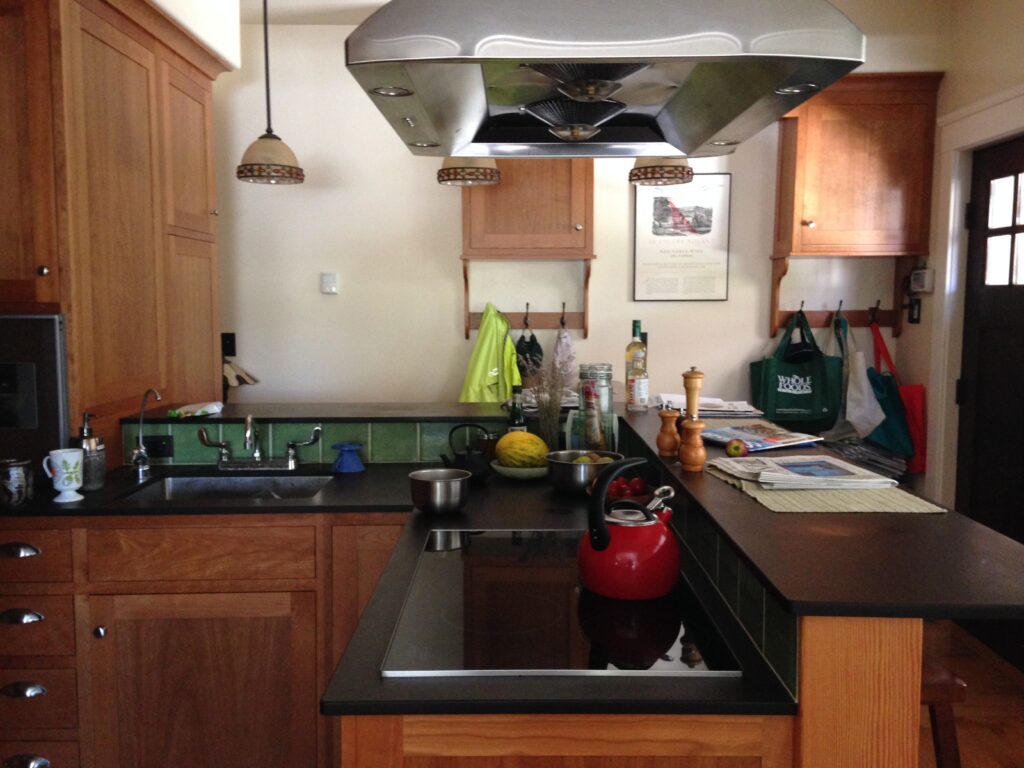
124 475 331 502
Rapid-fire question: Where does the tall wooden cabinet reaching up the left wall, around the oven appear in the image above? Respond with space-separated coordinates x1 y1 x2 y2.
0 0 227 456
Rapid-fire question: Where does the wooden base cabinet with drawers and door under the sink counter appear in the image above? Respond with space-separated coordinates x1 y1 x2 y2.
0 512 404 768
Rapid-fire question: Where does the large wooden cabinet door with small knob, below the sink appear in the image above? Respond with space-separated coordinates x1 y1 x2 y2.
79 592 318 768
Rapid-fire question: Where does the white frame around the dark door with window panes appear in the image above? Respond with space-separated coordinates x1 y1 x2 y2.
922 86 1024 507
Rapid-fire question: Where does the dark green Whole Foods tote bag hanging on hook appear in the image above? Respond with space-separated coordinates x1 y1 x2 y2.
751 311 843 432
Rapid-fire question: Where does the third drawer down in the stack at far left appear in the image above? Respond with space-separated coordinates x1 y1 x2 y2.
0 670 78 731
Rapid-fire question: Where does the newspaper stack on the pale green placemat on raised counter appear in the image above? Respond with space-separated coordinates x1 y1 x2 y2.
708 455 899 490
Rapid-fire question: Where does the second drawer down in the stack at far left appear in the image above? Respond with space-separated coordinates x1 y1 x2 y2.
0 595 75 659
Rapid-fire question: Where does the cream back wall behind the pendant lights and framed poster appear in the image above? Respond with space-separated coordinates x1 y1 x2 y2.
214 0 946 409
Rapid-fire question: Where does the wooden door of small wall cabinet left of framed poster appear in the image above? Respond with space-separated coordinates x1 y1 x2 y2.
462 158 594 259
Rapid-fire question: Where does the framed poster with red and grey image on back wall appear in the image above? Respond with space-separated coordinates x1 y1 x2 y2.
633 173 732 301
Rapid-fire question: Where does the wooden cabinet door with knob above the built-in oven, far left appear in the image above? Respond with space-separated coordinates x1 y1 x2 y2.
0 0 59 311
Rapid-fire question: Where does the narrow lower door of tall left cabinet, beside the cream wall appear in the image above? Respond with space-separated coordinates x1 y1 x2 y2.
167 236 223 402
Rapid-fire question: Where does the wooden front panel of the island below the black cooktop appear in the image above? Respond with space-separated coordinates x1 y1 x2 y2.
341 715 794 768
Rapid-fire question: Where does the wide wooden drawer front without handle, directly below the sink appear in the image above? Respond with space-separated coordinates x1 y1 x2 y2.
87 525 316 582
